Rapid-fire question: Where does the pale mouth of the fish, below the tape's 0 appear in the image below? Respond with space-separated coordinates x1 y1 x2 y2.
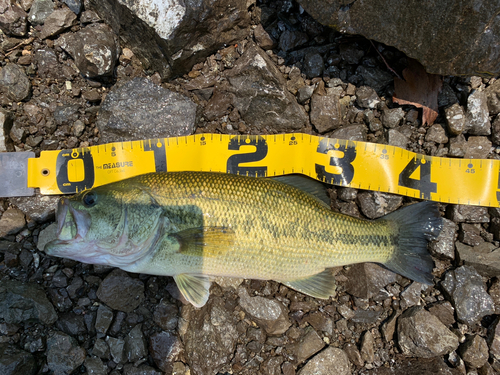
56 198 90 243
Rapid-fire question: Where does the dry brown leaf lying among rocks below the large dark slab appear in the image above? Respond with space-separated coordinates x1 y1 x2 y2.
392 59 442 125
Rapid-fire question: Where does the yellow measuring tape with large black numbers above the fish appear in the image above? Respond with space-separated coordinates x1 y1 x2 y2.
28 133 500 207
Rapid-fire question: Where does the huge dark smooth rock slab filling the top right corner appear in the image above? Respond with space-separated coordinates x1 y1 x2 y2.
299 0 500 76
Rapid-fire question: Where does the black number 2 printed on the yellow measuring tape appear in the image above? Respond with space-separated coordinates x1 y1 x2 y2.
226 135 268 177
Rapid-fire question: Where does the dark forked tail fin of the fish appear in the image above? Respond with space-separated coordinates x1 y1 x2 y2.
379 202 443 284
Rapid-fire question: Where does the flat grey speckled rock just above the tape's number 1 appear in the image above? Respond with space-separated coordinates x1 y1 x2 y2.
97 78 197 143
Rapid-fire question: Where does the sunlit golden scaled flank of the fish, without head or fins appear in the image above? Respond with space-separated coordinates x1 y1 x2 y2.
131 172 394 280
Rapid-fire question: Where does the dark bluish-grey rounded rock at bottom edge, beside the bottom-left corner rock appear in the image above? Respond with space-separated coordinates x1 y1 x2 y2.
47 332 86 375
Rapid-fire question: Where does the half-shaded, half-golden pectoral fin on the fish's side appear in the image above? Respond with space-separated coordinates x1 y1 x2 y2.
173 227 235 258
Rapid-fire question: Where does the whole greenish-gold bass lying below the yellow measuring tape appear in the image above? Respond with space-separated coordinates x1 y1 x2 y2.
45 172 443 307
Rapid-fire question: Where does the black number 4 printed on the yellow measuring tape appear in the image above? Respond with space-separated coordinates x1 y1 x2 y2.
399 157 437 199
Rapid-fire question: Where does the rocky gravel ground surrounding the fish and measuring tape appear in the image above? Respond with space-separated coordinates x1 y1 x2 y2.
0 1 500 375
